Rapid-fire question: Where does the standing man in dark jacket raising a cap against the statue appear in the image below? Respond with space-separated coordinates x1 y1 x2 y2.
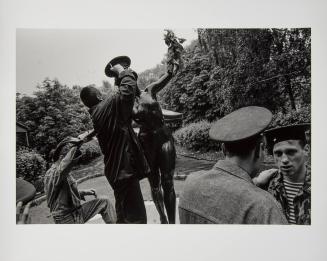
80 56 150 223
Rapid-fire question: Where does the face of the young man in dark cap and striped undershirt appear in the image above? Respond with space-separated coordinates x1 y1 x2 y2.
273 140 307 179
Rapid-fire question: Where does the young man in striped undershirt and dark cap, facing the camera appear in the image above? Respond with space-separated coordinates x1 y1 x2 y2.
254 124 311 225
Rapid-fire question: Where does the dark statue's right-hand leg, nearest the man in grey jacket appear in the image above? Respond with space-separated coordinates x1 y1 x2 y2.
159 138 176 224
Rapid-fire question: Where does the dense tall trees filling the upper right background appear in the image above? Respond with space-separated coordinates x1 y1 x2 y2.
161 29 311 123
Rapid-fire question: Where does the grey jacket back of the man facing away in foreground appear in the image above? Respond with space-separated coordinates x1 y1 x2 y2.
179 160 287 224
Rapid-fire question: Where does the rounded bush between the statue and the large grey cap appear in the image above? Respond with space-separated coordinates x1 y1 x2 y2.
173 121 220 151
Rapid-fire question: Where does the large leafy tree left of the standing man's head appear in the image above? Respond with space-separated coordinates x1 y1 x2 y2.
16 79 92 159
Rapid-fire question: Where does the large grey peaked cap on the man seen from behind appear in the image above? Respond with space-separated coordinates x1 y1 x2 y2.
209 106 272 143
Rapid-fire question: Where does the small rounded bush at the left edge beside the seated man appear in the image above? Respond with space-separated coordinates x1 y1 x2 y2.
16 148 46 192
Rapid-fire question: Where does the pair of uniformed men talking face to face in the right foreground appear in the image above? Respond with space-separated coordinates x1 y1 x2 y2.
179 106 311 225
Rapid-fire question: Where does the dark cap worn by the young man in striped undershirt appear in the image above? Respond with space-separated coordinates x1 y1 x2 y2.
264 123 310 154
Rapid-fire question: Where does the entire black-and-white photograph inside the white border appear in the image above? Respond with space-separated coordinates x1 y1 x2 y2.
16 28 311 225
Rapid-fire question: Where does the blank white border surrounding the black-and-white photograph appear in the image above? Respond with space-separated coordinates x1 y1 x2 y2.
0 0 327 261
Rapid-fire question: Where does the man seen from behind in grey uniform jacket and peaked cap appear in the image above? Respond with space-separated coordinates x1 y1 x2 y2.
179 106 287 224
